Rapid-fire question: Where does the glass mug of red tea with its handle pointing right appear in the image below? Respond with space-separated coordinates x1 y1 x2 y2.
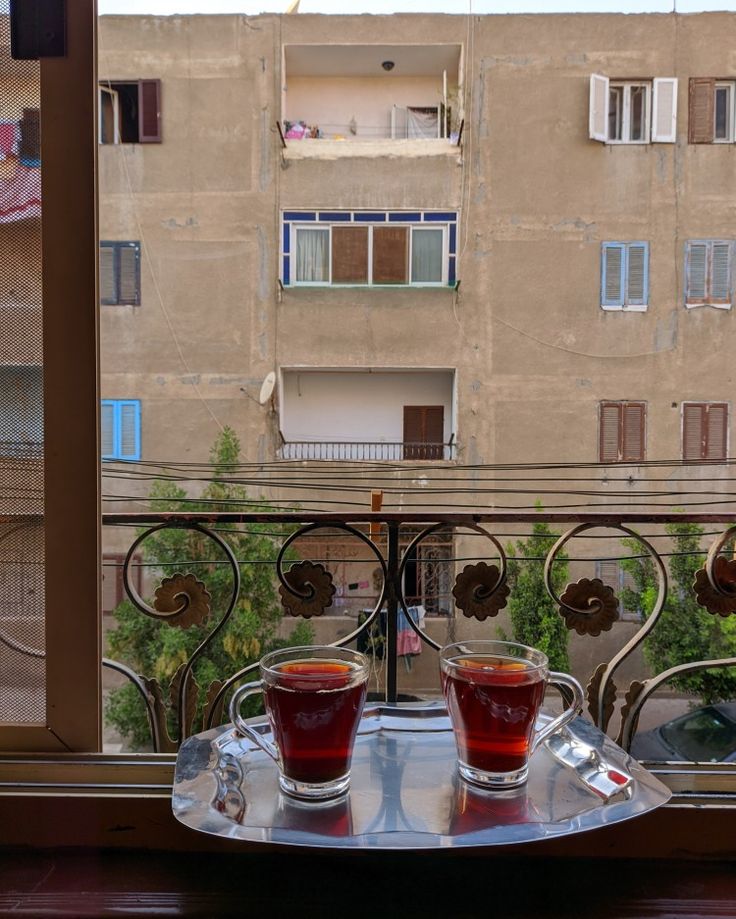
440 640 583 789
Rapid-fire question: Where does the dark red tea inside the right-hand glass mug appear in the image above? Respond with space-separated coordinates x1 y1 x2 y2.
442 655 545 773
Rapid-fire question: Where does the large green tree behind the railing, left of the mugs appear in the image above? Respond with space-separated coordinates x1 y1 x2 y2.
106 428 313 748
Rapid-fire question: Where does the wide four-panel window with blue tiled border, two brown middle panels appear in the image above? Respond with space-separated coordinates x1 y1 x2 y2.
282 211 457 287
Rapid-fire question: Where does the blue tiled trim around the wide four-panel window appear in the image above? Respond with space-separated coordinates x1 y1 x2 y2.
281 210 457 288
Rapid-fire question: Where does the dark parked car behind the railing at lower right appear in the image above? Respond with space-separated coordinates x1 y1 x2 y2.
631 702 736 763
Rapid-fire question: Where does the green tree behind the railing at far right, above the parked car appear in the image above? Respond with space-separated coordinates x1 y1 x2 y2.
621 523 736 702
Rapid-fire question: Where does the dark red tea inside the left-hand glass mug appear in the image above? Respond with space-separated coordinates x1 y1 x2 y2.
264 660 367 782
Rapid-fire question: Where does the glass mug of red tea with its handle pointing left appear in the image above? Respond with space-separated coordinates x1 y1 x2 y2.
230 645 369 800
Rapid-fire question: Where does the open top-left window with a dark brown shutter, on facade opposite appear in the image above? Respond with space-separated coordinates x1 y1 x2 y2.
99 80 161 144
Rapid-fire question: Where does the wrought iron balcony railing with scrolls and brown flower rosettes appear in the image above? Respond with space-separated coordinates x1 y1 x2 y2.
90 512 736 751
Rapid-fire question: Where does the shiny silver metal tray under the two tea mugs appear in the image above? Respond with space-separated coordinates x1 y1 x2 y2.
172 703 670 849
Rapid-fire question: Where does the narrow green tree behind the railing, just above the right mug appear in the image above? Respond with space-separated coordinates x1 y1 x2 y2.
507 522 570 672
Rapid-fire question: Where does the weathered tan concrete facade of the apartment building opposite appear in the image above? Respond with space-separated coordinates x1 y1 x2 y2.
93 13 736 688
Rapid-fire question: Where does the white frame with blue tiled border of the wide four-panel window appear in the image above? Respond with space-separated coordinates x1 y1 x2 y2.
280 211 457 290
